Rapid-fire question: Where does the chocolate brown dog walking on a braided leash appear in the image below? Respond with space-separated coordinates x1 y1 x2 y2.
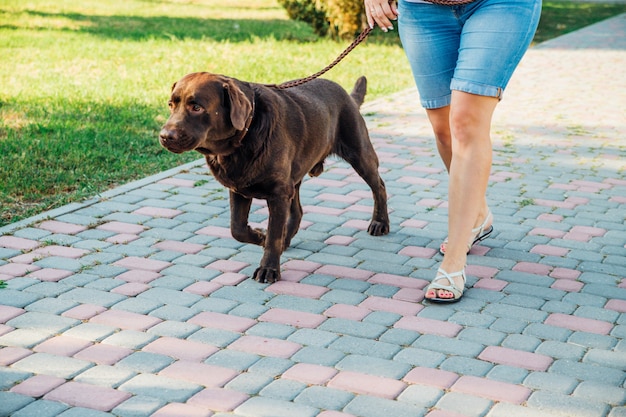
159 72 389 282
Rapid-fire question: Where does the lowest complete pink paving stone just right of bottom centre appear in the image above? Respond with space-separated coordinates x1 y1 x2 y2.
328 371 406 400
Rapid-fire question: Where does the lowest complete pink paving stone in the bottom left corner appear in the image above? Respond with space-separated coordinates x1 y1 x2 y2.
43 382 132 411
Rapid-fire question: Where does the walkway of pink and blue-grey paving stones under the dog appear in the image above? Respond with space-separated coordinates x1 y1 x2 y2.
0 15 626 417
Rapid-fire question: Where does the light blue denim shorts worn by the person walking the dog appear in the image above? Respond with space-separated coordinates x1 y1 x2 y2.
398 0 541 109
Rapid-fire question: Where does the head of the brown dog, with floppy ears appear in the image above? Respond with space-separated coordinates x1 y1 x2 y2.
159 72 253 155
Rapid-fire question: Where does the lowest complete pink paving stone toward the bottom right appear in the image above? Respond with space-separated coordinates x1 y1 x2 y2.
451 376 531 404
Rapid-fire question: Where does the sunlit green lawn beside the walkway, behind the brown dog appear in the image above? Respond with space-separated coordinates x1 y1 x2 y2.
0 0 626 226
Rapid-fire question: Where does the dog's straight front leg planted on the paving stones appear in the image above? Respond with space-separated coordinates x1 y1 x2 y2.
254 197 291 282
